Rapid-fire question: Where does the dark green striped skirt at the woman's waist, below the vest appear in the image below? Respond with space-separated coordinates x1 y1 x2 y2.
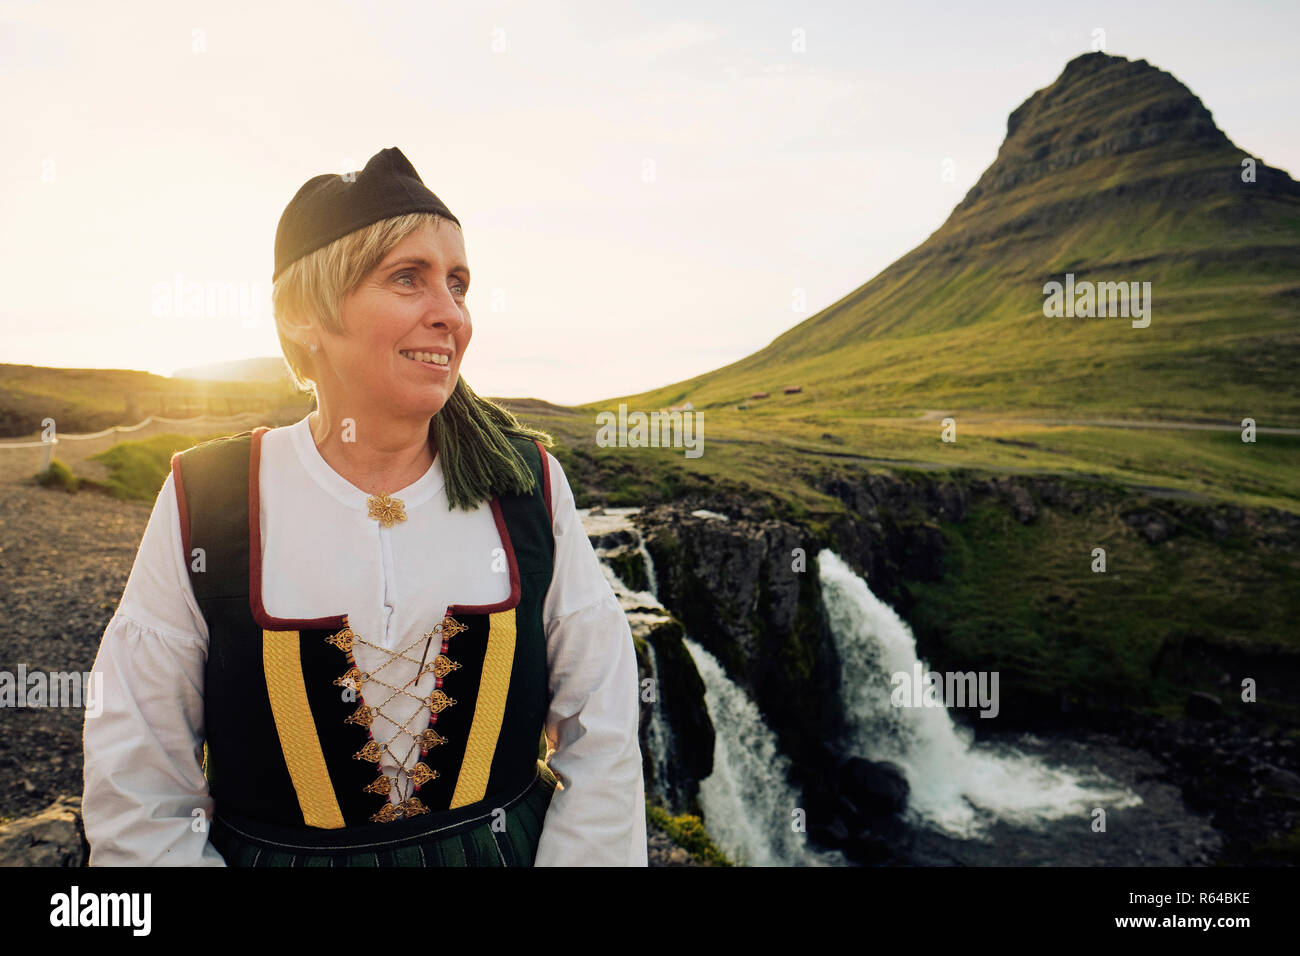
208 761 555 866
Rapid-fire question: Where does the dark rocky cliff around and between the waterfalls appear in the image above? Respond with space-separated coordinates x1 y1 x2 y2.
633 472 1300 861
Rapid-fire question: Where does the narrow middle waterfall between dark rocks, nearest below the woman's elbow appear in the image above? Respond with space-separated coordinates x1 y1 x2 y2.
685 639 845 866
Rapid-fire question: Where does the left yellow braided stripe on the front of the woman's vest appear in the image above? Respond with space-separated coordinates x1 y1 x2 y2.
261 631 343 830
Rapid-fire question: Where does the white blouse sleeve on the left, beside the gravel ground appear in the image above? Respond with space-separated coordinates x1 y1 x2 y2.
82 473 225 866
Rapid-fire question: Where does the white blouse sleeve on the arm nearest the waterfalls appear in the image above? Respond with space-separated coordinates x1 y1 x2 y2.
533 454 647 866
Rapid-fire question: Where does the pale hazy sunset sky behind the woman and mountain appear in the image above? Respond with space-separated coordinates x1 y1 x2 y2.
0 0 1300 403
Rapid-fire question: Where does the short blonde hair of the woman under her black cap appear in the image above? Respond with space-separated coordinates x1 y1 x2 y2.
270 212 459 393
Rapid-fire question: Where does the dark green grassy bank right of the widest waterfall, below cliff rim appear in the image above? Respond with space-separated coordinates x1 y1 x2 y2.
909 498 1300 717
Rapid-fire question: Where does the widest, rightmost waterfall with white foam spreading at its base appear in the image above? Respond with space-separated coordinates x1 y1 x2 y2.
818 550 1141 839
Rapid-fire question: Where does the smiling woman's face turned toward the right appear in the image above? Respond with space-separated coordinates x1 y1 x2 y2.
317 220 473 420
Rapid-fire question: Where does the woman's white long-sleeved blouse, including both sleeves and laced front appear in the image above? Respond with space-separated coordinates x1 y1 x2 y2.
82 416 646 866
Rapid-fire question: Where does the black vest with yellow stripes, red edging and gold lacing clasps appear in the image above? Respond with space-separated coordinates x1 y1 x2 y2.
172 427 555 829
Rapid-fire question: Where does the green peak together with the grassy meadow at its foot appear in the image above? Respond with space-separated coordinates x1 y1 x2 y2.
548 53 1300 507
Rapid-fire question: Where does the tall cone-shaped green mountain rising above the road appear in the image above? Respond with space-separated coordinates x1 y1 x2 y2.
606 53 1300 424
